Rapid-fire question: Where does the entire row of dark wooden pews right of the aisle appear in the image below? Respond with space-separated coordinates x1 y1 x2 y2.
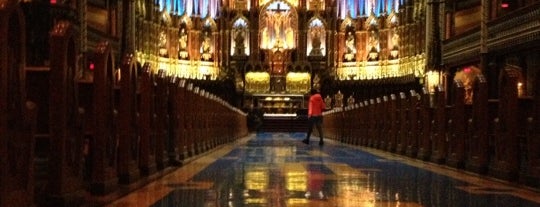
323 65 540 188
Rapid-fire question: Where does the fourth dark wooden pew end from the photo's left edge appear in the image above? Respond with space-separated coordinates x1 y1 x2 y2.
118 54 139 184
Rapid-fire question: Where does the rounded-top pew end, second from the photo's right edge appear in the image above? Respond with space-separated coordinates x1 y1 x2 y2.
489 65 520 180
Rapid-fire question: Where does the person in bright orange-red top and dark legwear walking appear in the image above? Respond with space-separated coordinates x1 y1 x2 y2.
302 89 326 146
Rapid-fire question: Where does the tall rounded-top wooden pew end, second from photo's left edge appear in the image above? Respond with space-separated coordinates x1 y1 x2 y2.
43 21 84 206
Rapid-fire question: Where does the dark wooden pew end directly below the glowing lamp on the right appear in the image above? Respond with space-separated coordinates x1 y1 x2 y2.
431 87 448 163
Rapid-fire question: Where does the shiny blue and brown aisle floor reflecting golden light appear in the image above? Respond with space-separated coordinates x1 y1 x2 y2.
105 133 540 207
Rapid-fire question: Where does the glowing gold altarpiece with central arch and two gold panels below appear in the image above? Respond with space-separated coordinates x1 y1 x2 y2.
246 1 311 95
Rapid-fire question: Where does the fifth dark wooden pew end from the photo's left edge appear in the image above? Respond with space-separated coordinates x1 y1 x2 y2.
139 63 157 176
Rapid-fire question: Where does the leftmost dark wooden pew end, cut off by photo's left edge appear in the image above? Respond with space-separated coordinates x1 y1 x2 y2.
0 1 37 207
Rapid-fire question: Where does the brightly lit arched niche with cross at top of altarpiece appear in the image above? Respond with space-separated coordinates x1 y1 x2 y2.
259 0 298 49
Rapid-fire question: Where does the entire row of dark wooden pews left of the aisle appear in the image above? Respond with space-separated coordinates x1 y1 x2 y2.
0 6 248 207
